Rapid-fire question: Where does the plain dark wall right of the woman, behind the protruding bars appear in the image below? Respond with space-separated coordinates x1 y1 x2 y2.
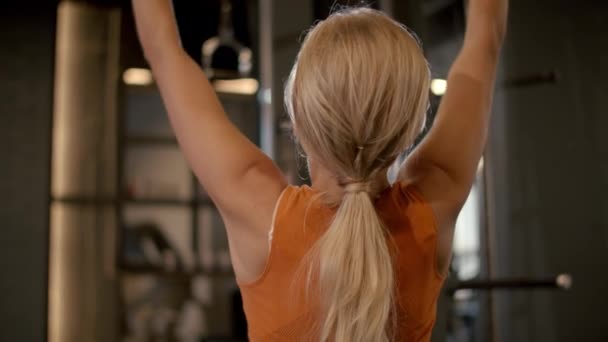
488 0 608 342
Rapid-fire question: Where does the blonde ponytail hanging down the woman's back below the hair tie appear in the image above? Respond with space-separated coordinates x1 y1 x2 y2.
315 184 394 342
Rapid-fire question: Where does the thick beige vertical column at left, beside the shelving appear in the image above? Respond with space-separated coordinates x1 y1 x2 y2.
48 1 121 342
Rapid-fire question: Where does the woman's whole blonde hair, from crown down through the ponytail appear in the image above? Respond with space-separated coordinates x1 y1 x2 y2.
285 8 430 342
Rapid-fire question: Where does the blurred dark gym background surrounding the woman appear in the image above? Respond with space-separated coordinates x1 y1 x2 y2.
0 0 608 342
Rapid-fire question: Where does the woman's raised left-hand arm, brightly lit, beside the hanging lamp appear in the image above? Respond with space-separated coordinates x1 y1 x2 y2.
133 0 286 275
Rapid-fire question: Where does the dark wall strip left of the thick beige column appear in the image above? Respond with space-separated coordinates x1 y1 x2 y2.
0 1 56 342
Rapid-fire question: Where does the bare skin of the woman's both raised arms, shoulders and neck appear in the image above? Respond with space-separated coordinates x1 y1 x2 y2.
133 0 508 282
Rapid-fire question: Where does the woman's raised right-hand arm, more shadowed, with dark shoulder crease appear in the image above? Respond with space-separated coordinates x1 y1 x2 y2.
400 0 508 270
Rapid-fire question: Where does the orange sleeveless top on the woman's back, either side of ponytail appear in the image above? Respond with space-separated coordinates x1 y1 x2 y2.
239 183 443 342
